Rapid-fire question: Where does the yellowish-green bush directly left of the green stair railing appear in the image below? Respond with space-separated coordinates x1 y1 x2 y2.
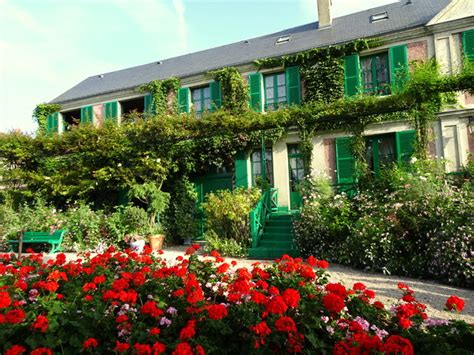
202 188 260 247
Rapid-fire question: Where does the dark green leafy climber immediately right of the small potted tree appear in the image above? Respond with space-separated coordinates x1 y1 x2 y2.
164 177 198 243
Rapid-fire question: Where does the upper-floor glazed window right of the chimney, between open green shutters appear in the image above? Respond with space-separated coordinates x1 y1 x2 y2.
360 53 390 95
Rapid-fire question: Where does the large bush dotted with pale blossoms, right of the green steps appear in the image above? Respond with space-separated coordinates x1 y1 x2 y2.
295 161 474 287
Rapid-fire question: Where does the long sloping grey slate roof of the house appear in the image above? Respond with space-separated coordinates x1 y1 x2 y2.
51 0 450 103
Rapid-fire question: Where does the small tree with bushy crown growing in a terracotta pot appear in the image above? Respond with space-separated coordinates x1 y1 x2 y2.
129 182 169 250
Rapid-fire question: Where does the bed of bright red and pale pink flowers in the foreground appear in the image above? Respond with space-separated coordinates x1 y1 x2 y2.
0 247 474 354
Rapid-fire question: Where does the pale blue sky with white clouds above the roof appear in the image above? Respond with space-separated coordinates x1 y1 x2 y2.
0 0 397 132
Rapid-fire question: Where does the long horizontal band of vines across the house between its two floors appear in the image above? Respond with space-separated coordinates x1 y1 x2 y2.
0 59 474 206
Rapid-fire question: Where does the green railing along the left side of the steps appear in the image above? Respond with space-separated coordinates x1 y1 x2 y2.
250 189 278 248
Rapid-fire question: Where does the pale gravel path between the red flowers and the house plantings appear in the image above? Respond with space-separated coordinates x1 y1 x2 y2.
41 246 474 324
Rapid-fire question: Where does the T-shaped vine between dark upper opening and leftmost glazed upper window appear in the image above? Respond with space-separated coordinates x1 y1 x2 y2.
138 77 181 115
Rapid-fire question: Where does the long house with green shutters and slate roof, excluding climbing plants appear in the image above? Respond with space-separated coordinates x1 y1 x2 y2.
48 0 474 248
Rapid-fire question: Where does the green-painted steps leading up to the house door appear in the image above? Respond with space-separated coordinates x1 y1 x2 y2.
249 212 298 259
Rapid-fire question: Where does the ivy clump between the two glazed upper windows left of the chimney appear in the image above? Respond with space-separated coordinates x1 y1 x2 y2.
209 67 249 114
